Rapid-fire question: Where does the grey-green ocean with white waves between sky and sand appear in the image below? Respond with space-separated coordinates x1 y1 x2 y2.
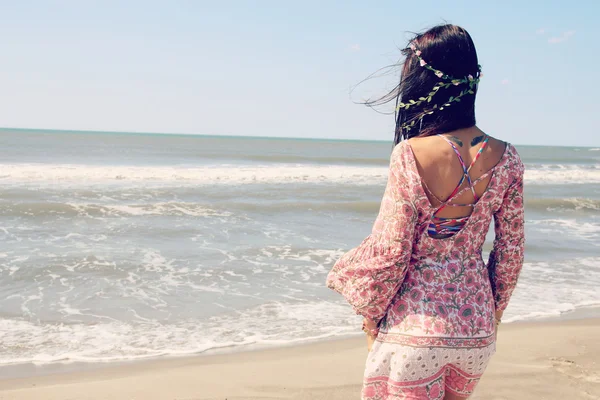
0 129 600 365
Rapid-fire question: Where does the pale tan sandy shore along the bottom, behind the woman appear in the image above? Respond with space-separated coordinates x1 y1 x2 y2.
0 319 600 400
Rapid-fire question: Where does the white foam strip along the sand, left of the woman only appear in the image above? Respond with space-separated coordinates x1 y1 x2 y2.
0 301 359 365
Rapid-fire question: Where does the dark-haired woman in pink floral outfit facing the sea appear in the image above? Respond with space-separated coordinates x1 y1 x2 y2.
327 25 524 400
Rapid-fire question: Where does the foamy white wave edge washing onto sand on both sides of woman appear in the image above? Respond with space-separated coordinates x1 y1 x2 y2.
0 270 600 365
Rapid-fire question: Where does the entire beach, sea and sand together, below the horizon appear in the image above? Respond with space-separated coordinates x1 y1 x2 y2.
0 129 600 400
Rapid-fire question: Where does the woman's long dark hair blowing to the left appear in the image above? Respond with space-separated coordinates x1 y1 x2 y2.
365 25 479 144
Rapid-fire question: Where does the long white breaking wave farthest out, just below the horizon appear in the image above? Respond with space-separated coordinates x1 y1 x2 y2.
0 164 600 186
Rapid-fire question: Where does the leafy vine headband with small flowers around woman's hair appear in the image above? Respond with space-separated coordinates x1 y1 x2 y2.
396 43 483 131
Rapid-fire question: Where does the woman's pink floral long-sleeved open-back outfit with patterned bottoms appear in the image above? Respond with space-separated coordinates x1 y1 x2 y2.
327 141 524 400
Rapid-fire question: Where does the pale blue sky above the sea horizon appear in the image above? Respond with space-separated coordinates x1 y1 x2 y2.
0 0 600 146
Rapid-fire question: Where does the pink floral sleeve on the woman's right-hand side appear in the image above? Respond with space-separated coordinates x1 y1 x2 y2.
488 164 525 311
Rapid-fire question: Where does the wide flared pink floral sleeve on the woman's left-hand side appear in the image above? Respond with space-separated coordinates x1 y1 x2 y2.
327 145 417 321
